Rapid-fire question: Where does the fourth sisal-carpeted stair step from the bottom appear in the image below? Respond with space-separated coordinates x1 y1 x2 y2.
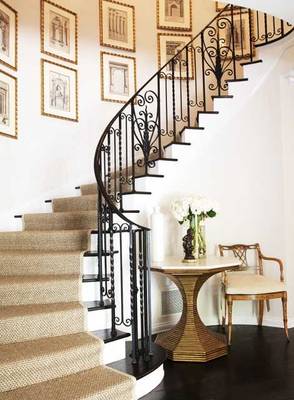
0 275 80 307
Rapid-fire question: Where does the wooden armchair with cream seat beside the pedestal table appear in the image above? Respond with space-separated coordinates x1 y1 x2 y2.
219 243 289 345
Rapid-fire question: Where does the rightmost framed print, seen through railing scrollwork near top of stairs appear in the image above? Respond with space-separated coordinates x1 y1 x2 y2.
219 12 254 60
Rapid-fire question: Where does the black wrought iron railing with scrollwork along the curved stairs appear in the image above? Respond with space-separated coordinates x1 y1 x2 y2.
95 5 293 362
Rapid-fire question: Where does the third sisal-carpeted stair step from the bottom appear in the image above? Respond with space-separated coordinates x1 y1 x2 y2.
0 302 86 344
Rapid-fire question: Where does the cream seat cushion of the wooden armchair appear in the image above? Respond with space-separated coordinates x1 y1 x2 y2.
226 272 286 295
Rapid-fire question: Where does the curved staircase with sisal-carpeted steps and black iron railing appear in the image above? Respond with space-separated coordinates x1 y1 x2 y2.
0 6 293 400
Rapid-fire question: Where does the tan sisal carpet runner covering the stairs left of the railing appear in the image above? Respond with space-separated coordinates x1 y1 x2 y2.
0 185 135 400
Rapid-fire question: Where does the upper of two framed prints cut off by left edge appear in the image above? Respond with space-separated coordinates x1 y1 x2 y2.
0 0 17 70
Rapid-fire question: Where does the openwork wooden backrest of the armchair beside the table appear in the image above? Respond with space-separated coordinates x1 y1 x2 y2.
218 243 263 275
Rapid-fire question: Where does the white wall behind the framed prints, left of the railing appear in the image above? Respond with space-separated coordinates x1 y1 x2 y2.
0 0 214 230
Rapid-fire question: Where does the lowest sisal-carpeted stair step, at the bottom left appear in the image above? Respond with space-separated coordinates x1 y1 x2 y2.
0 366 136 400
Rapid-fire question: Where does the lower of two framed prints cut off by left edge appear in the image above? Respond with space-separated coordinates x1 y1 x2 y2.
0 71 17 139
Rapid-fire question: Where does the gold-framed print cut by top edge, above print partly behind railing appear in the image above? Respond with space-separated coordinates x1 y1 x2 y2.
157 0 192 31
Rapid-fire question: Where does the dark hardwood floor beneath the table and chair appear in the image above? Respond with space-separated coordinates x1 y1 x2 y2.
143 325 294 400
